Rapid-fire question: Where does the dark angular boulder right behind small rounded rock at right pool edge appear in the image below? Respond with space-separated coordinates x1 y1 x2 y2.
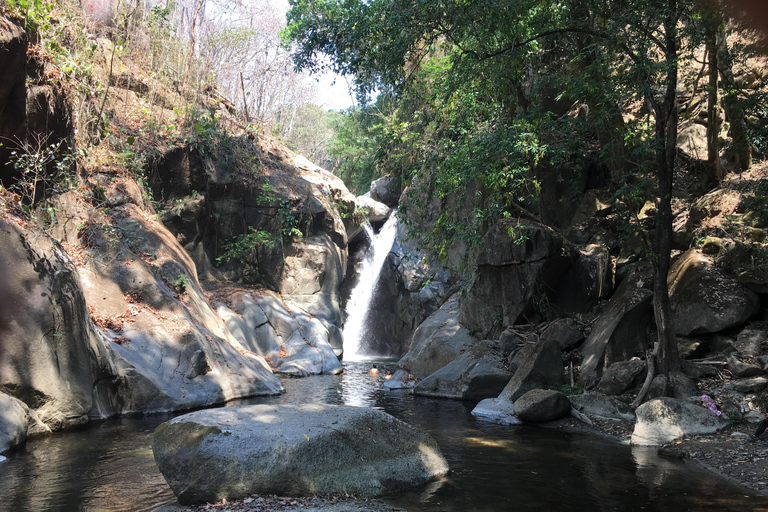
499 340 564 402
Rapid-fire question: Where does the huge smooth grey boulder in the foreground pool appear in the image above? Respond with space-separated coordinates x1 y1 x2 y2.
152 405 448 504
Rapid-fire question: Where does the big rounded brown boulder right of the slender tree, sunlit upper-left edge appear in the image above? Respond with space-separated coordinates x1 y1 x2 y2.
668 249 760 336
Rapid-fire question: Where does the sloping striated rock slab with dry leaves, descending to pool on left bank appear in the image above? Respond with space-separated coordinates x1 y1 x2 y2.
78 204 283 414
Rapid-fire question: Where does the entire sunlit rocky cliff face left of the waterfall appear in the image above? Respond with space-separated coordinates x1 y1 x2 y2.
0 13 362 452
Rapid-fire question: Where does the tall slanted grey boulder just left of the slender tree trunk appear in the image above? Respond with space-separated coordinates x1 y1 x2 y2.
579 272 653 388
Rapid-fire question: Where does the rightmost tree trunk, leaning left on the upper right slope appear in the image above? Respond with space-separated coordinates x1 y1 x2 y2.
717 23 752 171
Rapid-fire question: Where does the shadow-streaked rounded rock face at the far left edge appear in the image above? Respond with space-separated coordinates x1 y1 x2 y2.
0 220 116 430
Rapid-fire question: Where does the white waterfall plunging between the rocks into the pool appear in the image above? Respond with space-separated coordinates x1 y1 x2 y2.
343 210 397 361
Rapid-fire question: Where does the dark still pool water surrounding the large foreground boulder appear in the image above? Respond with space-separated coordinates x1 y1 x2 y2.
0 362 768 512
